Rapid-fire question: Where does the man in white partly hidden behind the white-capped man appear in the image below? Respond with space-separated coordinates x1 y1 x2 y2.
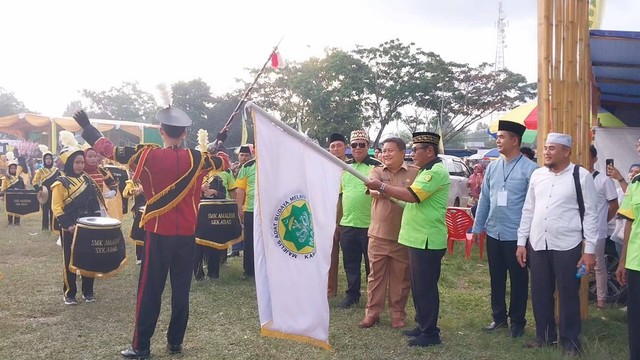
589 145 618 310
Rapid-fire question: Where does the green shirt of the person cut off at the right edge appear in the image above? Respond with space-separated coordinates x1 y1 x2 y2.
618 176 640 271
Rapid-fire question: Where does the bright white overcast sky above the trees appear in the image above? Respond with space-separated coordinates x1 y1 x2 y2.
0 0 640 116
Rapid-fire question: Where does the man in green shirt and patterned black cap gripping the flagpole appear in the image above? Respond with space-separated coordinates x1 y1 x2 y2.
366 132 451 347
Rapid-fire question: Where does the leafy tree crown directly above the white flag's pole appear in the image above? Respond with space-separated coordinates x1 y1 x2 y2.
251 49 369 145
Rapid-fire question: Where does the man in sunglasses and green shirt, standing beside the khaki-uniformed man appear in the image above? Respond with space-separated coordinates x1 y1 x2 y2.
340 130 382 309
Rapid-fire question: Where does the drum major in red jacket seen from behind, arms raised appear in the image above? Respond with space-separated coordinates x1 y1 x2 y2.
74 107 229 359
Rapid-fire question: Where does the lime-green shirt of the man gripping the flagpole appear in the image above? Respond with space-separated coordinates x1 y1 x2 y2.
398 158 451 250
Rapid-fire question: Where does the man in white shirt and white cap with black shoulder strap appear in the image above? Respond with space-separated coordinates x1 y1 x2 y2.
516 133 598 355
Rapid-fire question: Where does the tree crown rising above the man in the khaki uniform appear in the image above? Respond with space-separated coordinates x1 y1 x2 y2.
353 39 427 147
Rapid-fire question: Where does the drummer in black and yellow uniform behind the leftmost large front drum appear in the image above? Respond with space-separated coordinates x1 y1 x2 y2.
51 150 104 305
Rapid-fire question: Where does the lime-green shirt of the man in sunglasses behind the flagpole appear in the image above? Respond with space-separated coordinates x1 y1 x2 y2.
340 156 380 229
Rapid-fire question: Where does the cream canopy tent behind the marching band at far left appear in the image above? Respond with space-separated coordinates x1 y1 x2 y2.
0 113 161 153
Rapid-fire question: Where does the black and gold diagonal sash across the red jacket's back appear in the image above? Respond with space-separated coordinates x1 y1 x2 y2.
141 149 205 226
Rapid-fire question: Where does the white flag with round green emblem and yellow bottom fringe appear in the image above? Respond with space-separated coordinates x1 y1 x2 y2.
252 106 342 349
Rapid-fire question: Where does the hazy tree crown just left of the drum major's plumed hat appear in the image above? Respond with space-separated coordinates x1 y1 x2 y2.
81 82 158 123
